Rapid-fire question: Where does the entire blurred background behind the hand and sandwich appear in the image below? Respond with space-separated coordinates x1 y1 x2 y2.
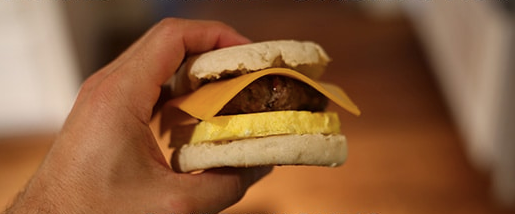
0 0 515 214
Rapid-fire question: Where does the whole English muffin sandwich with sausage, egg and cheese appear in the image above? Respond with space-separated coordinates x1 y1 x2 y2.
170 40 360 172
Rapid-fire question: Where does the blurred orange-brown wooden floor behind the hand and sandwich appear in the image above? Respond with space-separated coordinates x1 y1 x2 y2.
0 1 513 214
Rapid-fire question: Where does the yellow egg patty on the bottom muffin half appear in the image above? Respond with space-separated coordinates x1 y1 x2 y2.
183 111 340 144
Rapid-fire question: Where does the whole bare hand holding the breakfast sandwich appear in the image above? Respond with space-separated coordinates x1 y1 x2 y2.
4 18 272 214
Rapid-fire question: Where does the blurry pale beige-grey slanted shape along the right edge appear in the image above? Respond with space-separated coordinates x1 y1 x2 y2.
405 1 515 205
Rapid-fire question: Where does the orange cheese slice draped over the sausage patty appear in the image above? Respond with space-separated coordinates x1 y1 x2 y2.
170 68 361 120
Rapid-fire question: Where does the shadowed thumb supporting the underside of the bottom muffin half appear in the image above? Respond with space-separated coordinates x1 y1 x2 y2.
170 166 273 213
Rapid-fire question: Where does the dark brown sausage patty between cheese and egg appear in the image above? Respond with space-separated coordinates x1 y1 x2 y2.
218 75 328 115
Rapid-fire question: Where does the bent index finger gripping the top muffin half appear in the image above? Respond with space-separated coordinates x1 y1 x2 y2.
125 18 250 85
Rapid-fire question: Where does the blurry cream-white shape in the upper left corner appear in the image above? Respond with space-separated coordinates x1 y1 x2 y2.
0 1 79 136
